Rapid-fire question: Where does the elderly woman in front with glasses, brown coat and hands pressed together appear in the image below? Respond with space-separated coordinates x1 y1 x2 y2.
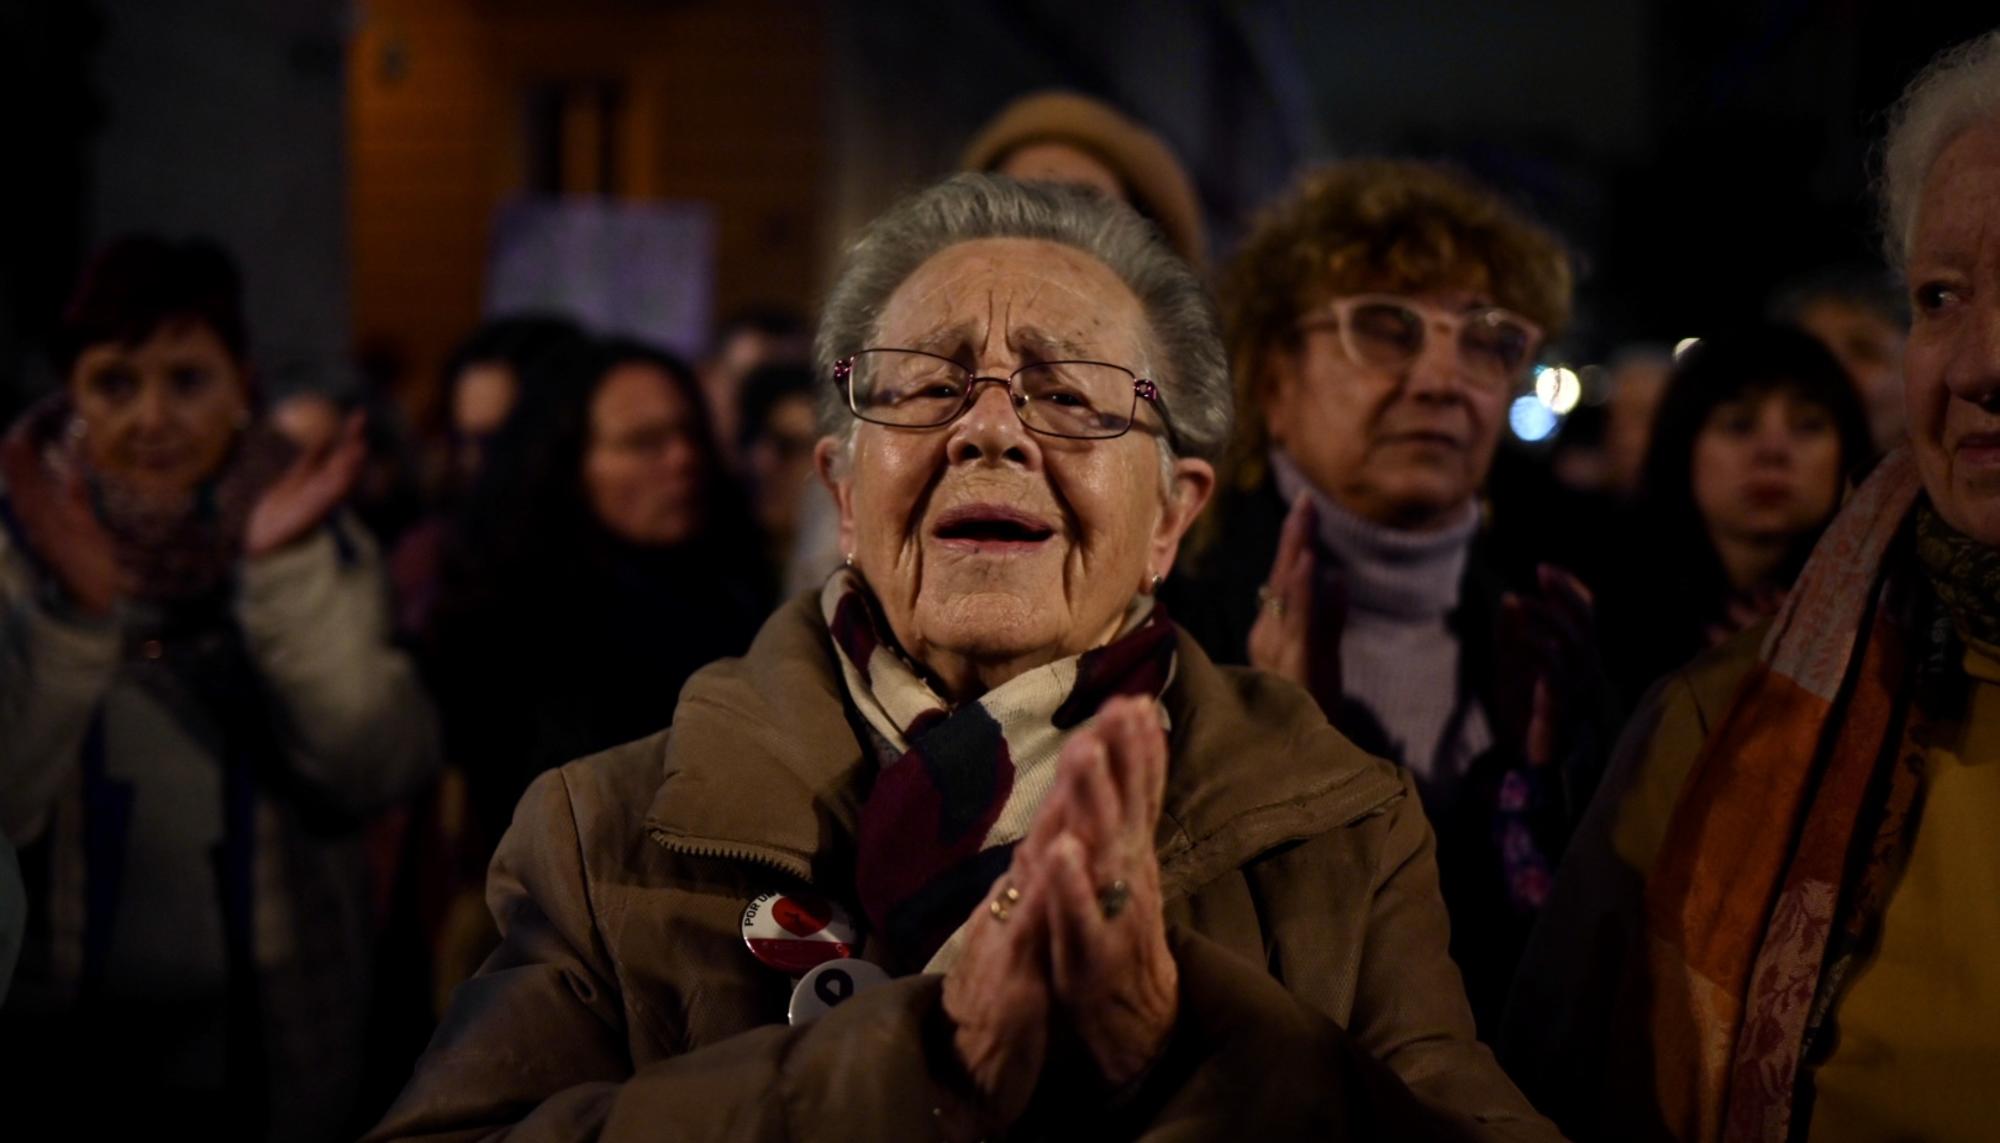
376 176 1550 1139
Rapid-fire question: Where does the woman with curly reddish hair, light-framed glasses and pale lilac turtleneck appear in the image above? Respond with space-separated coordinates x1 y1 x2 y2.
1168 160 1606 1027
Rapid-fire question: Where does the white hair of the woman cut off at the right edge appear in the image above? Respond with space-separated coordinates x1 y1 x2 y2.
1880 30 2000 266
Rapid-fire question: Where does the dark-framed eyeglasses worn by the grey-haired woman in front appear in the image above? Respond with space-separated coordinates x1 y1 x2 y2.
834 350 1174 442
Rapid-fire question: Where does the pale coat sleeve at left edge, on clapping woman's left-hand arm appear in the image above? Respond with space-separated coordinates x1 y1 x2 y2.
0 532 120 845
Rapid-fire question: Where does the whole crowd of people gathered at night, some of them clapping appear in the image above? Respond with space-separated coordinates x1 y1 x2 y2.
0 22 2000 1141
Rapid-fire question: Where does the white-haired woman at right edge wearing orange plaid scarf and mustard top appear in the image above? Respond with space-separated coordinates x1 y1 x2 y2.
1506 34 2000 1141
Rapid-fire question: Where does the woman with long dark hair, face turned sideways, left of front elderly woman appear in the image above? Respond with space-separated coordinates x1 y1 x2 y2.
432 342 770 863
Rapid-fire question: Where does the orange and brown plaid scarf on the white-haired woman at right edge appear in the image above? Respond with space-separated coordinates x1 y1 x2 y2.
1640 450 1950 1141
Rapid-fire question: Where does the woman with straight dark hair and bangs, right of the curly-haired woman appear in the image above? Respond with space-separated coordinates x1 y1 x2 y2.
1600 324 1874 701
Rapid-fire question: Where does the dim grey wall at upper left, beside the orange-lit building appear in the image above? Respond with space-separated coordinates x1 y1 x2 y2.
84 0 348 390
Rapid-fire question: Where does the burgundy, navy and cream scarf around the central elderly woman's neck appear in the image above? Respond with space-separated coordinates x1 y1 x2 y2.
820 568 1174 971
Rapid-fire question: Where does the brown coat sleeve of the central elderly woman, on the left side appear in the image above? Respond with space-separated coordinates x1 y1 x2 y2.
368 769 992 1143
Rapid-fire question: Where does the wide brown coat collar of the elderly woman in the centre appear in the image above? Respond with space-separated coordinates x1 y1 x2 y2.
646 593 1404 899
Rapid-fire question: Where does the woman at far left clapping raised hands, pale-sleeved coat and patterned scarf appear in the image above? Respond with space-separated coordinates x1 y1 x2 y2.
0 238 436 1139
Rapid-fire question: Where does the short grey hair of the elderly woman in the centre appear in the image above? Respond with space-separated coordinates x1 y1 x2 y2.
812 174 1232 464
